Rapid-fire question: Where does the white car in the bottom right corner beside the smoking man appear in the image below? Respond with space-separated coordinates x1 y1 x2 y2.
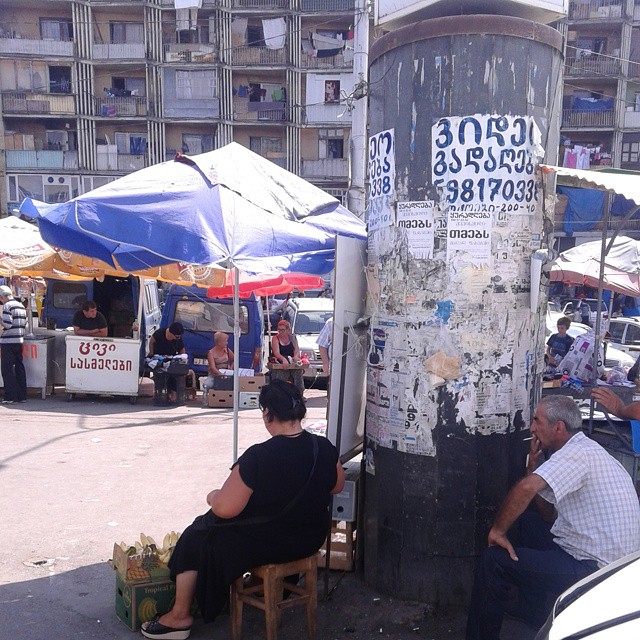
536 552 640 640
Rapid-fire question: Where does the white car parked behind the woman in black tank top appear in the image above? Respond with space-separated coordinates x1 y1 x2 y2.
283 297 333 381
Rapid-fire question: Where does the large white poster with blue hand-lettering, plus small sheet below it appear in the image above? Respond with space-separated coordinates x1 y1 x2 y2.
431 114 544 267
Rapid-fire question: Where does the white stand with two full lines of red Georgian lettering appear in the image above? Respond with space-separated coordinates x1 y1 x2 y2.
65 335 140 404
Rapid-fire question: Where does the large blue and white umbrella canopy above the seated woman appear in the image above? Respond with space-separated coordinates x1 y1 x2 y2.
20 143 366 274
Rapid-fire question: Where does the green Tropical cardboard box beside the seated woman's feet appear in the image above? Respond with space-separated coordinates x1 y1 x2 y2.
116 573 176 631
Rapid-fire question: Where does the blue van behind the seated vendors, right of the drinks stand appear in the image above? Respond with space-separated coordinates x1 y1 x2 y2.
162 285 263 376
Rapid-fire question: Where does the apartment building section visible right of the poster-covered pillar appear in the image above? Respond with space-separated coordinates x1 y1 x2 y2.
554 0 640 245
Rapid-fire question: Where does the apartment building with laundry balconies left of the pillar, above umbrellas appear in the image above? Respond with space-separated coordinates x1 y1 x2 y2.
0 0 356 215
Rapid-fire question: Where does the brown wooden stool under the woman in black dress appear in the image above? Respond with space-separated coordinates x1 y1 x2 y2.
231 553 318 640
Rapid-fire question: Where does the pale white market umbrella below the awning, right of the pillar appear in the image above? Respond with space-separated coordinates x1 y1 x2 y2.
544 236 640 296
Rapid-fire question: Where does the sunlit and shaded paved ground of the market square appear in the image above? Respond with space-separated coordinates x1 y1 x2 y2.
0 391 533 640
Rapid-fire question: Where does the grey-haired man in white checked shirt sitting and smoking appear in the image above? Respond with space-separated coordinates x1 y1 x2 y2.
466 396 640 640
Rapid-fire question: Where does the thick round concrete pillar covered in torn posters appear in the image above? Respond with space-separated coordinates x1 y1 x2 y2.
364 15 563 607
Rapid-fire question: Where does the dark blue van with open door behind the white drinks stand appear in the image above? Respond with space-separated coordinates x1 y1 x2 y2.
42 276 162 350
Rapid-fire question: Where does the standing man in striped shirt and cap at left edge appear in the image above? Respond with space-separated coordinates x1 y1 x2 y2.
0 285 27 404
